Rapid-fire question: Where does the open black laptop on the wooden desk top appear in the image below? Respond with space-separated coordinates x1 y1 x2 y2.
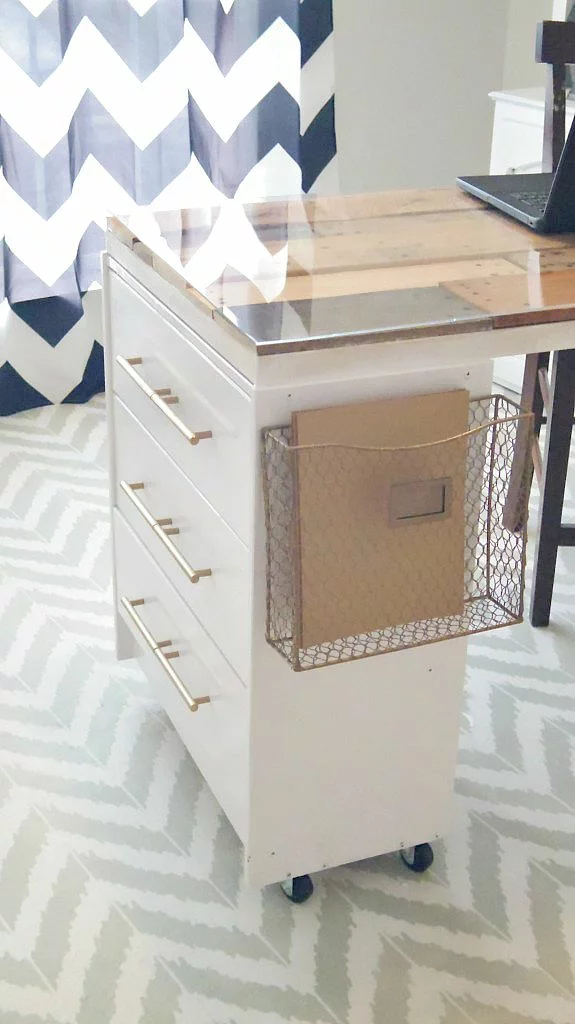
457 111 575 233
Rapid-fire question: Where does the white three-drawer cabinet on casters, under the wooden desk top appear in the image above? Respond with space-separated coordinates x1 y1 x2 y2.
104 218 490 886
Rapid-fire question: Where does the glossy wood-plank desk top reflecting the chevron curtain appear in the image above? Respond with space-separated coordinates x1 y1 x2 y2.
108 188 575 355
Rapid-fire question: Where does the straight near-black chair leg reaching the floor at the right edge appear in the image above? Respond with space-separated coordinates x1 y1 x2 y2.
531 349 575 626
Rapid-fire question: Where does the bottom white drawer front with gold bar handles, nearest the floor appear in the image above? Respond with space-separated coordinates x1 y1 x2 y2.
113 512 249 838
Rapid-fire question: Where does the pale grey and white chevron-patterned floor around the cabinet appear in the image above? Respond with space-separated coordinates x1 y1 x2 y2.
0 398 575 1024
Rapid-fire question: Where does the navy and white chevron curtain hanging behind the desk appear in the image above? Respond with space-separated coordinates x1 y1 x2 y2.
0 0 336 416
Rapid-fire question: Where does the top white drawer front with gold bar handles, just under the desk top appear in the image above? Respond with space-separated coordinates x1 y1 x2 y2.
107 271 252 543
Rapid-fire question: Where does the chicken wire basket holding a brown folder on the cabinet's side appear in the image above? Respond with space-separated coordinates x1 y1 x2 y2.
262 395 532 672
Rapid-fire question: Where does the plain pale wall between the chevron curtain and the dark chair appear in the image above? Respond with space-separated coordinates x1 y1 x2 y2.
334 0 551 191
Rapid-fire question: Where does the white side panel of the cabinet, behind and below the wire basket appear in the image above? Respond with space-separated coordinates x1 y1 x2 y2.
247 364 491 885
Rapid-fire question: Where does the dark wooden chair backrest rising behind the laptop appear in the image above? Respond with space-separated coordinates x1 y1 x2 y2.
535 22 575 171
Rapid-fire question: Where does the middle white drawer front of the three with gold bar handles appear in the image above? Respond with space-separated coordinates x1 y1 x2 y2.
114 397 251 679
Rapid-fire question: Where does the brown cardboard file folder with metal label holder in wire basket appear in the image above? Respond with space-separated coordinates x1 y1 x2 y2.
292 390 470 648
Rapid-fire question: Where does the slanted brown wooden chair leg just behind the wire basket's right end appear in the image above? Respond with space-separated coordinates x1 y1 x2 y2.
503 352 549 534
